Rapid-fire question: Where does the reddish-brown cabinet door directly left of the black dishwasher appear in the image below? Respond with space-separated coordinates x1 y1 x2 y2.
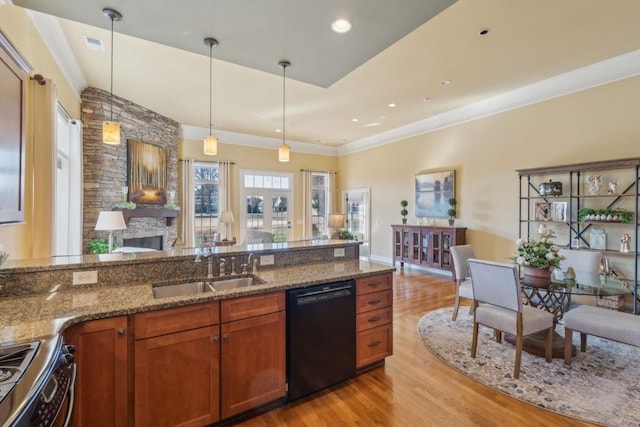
220 311 285 419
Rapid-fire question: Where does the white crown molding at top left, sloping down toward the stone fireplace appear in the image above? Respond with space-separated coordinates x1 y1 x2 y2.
25 9 87 99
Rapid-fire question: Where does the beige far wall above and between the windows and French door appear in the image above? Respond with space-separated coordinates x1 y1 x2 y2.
178 139 340 239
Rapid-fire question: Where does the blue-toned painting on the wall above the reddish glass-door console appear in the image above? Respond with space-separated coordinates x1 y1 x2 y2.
415 170 456 218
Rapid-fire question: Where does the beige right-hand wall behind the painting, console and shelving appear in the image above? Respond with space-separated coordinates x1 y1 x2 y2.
338 77 640 273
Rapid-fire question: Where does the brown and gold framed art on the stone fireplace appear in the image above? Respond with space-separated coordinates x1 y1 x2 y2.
127 139 167 205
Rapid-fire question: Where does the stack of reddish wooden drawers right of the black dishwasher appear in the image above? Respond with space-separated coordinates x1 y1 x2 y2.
356 273 393 369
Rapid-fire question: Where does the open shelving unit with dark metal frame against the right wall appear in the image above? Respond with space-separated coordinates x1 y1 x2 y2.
516 158 640 314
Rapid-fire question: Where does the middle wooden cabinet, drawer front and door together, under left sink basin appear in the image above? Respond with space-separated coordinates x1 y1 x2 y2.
134 302 220 427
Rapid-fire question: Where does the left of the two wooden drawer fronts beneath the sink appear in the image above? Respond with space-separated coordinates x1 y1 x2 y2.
135 301 220 340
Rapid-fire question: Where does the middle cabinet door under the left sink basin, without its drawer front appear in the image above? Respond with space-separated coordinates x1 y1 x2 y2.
134 325 220 427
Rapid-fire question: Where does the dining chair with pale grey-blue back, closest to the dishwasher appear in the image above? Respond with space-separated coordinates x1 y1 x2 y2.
467 258 554 378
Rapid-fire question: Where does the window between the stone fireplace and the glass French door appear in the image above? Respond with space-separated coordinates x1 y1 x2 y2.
193 163 219 246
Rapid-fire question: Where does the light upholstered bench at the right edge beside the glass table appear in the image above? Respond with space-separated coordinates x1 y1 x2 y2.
562 305 640 365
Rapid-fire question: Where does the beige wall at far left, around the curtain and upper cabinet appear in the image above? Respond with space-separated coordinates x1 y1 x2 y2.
0 6 80 259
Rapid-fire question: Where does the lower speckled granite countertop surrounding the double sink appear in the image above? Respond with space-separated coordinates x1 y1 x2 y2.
0 260 395 343
